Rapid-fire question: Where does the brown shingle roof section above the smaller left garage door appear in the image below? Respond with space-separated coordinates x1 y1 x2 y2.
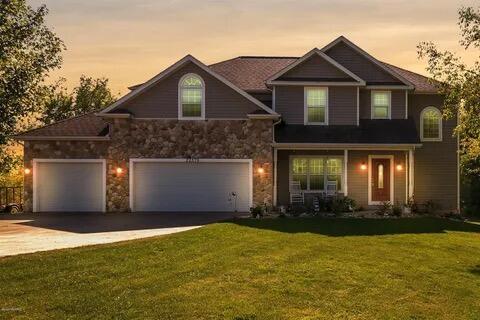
15 113 108 140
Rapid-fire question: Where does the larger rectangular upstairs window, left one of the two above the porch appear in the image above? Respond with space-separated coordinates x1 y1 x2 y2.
304 87 328 125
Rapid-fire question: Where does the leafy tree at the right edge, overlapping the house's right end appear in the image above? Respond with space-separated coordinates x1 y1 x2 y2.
417 7 480 176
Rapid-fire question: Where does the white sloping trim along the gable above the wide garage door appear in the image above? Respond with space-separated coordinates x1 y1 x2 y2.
99 55 278 115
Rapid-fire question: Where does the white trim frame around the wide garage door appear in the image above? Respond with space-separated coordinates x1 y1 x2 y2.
128 158 253 212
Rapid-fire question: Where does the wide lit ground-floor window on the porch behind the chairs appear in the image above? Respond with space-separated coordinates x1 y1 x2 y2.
290 156 343 191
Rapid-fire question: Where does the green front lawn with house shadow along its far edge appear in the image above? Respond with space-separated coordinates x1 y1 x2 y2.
0 218 480 320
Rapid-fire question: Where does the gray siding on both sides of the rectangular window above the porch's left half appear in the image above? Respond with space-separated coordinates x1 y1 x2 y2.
275 86 357 125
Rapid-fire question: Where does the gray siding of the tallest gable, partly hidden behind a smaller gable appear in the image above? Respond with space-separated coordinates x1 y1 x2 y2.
326 42 399 82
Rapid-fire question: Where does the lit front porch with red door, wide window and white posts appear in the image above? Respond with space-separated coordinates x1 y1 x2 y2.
274 144 414 209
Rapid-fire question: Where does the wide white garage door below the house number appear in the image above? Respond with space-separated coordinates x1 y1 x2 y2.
130 159 252 212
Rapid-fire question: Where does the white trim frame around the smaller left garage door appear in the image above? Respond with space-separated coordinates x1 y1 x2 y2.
32 159 107 212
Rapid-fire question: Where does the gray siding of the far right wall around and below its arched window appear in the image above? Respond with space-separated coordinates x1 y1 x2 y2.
408 94 458 211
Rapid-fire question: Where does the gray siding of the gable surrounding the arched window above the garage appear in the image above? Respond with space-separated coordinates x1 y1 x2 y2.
122 63 260 119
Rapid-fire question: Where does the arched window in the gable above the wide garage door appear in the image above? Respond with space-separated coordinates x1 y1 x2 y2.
178 73 205 120
